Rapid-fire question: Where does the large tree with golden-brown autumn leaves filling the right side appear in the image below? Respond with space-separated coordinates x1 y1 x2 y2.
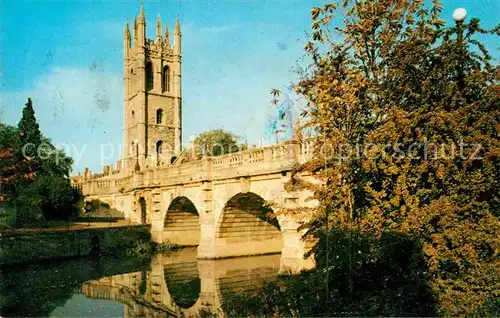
290 0 500 315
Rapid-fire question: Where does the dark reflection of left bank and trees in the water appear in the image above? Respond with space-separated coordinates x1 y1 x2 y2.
0 257 151 317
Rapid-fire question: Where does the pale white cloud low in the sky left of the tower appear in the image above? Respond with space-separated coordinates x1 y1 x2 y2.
1 65 123 171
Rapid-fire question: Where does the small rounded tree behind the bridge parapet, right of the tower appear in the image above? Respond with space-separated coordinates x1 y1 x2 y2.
194 129 246 156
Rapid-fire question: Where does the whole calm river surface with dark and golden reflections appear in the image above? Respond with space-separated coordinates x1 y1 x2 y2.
0 248 280 317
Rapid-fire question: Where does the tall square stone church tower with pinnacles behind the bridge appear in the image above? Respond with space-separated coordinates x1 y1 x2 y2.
123 6 182 171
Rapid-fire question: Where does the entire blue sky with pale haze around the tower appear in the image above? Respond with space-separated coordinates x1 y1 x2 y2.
0 0 500 171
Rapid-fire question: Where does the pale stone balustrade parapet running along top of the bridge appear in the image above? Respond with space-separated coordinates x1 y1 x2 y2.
73 137 316 195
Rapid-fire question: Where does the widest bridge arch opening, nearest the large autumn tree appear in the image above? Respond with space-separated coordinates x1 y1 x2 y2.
215 192 283 257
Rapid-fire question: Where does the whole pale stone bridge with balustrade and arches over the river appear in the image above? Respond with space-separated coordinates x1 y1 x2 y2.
73 138 316 270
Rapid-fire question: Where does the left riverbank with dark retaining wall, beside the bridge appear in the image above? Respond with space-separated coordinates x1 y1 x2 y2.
0 222 151 267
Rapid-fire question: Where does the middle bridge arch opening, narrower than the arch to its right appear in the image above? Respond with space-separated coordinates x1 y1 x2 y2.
163 196 200 246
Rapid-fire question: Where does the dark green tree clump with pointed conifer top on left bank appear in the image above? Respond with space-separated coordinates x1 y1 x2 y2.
0 99 81 227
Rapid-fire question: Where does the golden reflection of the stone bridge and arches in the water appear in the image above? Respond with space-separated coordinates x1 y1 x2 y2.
77 249 281 317
